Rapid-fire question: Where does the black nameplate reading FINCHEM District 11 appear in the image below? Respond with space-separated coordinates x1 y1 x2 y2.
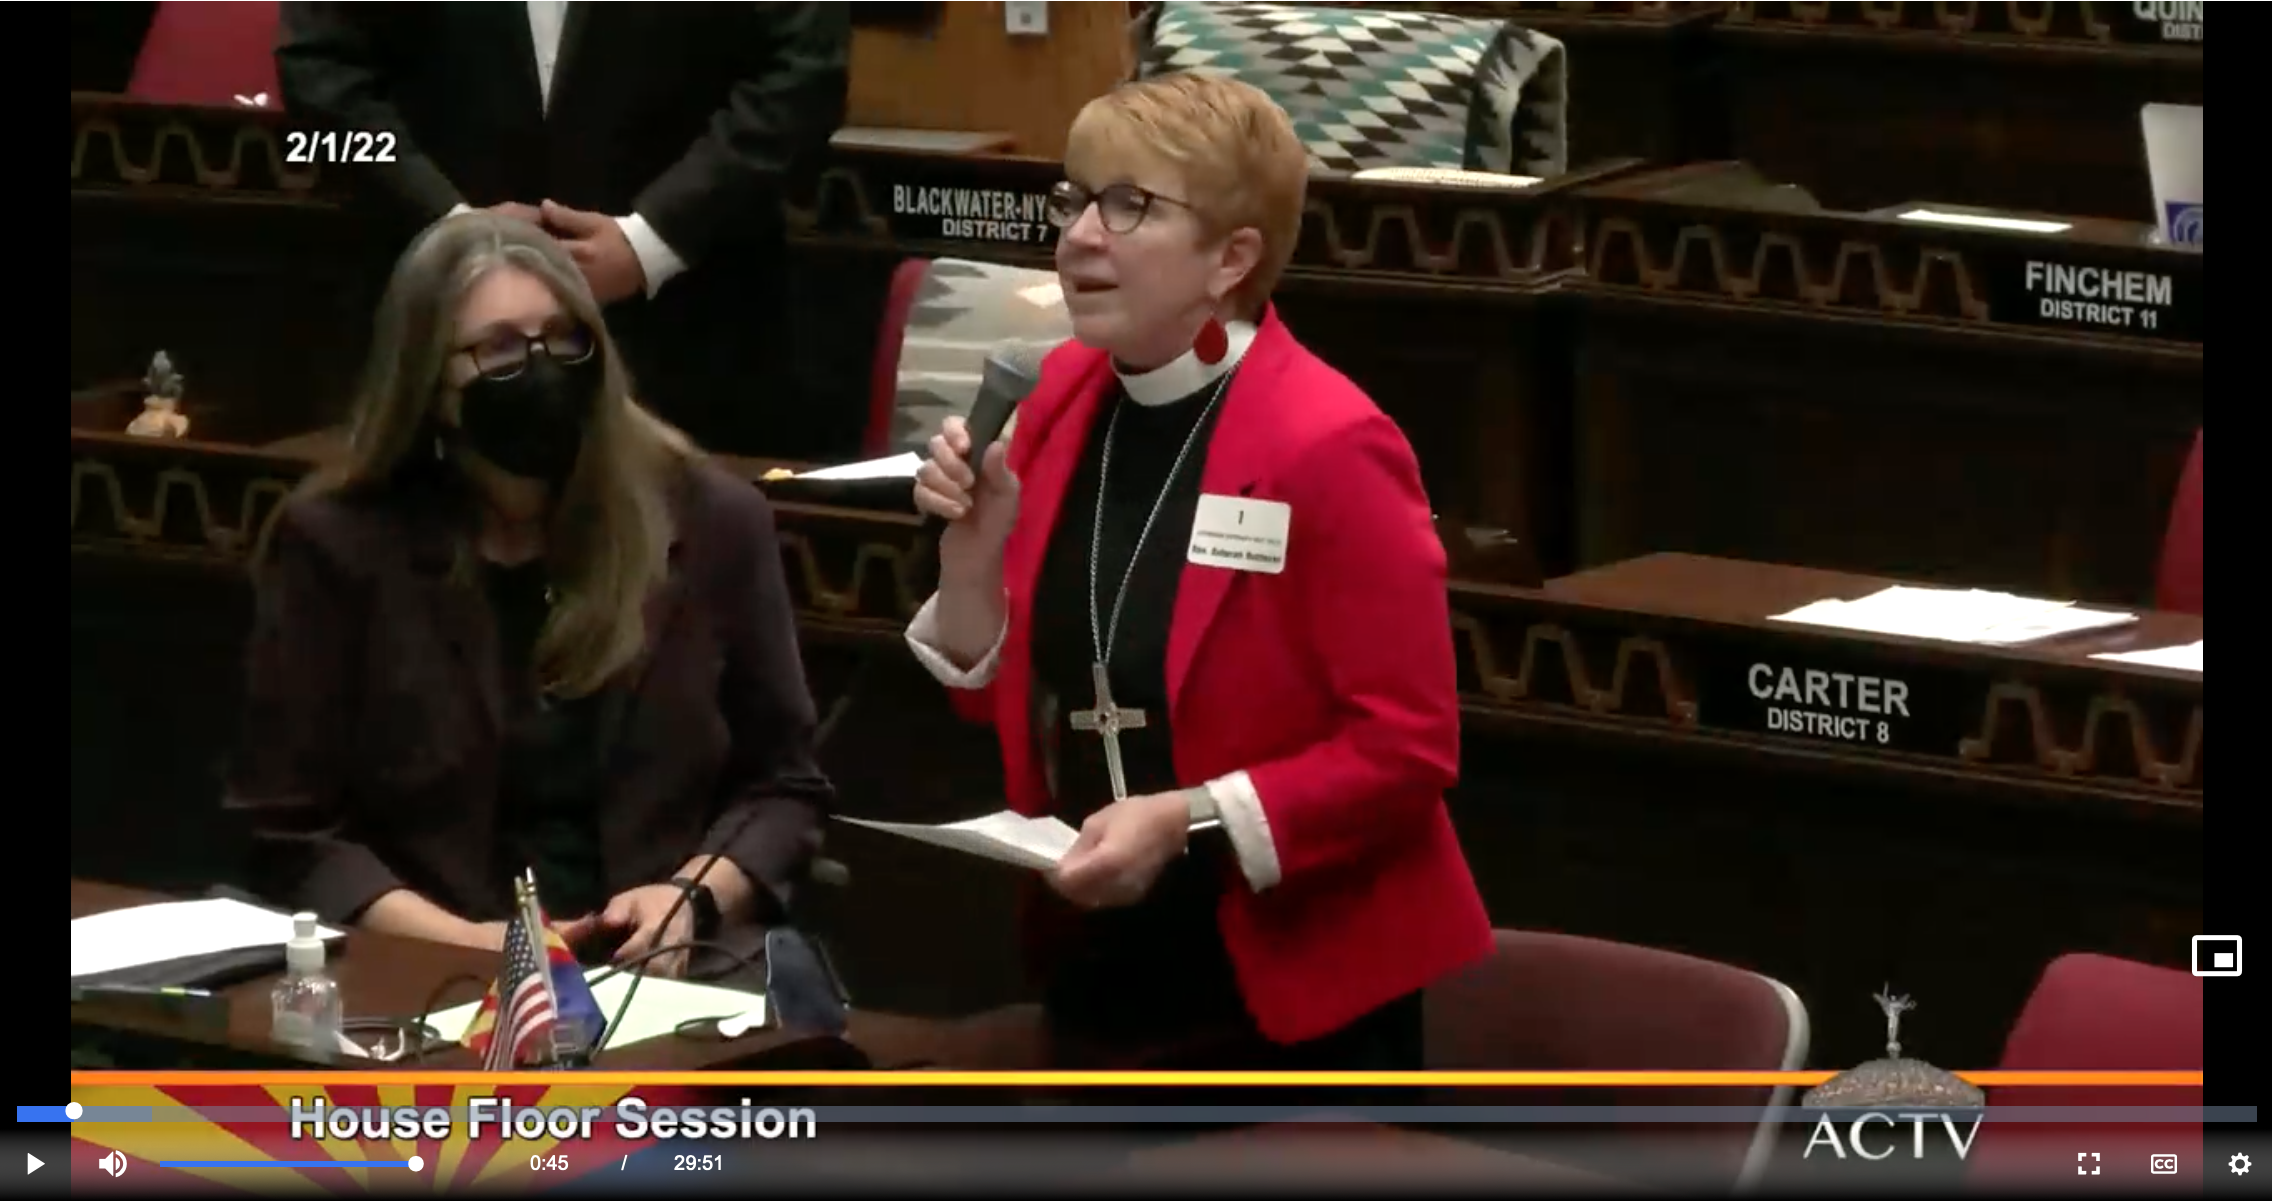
1990 245 2202 343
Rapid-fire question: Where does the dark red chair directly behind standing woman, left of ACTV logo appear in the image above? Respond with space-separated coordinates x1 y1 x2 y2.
1425 932 1809 1188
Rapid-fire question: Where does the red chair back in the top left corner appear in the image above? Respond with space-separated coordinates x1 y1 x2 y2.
127 2 284 109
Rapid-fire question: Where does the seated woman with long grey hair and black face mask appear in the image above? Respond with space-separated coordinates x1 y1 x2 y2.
227 214 829 973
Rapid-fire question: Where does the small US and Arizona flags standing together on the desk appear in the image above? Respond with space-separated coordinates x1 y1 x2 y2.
461 875 607 1072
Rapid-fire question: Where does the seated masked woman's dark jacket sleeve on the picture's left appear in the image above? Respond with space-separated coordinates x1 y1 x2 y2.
223 507 402 923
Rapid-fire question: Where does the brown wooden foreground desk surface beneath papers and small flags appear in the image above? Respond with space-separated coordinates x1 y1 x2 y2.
70 879 1043 1072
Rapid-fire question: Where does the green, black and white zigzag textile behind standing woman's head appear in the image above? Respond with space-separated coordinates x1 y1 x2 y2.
1136 0 1568 177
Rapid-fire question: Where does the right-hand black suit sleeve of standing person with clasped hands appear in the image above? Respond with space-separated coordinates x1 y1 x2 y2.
632 5 852 264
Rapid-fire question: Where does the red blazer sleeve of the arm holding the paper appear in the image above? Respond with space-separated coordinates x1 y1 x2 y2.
1245 414 1459 882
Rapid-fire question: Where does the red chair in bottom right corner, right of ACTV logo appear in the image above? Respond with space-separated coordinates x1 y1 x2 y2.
1970 954 2202 1195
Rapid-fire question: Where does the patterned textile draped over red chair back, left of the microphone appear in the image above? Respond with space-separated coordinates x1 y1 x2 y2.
886 259 1072 454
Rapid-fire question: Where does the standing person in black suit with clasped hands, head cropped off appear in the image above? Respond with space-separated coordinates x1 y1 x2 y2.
277 2 857 459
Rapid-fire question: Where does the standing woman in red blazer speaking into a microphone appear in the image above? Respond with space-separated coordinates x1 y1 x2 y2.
909 75 1490 1070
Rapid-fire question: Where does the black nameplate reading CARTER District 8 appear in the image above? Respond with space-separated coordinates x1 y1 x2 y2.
1697 641 1986 754
